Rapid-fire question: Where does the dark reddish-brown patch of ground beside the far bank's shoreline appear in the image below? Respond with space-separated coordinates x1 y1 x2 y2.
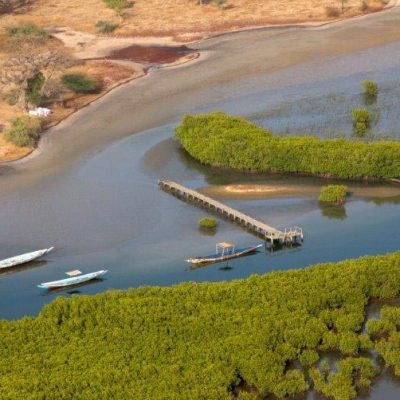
106 45 194 64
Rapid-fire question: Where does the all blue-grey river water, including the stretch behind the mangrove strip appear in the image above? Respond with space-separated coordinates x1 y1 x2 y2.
0 11 400 400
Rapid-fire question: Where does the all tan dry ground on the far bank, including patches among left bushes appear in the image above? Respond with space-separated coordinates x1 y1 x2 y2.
0 0 383 162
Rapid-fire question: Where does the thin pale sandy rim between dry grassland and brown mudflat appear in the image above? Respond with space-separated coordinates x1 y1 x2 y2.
0 0 400 167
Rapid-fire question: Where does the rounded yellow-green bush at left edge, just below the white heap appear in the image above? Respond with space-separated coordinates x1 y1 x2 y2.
4 115 41 147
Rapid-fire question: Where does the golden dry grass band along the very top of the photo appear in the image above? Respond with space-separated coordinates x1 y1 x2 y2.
0 0 383 37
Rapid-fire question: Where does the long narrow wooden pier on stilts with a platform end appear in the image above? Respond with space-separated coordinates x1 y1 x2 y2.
158 180 303 245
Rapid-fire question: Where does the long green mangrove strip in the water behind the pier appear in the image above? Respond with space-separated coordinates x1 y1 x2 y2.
176 112 400 179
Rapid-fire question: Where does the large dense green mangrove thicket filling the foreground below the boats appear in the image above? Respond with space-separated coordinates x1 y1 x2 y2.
0 253 400 400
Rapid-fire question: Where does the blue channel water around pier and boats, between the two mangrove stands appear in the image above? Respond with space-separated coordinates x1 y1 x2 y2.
0 122 400 318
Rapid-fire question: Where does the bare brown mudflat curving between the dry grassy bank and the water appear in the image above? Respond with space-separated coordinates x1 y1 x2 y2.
0 8 400 192
